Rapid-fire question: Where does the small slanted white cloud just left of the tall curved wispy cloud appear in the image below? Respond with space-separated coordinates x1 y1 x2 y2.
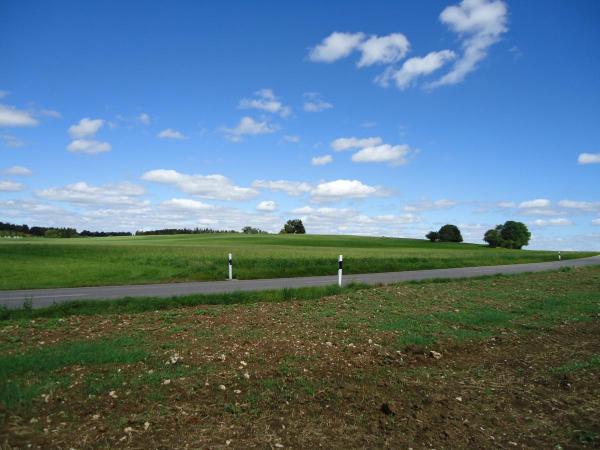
375 50 456 89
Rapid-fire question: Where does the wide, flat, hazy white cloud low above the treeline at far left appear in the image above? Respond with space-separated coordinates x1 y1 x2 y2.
36 181 147 206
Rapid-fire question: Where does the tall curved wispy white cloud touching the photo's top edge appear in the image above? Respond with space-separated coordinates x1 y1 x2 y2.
429 0 508 87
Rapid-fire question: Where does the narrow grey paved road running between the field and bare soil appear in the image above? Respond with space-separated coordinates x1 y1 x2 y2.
0 255 600 308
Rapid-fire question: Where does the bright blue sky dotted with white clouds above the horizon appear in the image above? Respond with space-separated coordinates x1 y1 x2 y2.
0 0 600 249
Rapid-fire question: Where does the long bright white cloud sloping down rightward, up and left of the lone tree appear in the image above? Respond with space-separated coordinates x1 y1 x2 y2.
142 169 258 200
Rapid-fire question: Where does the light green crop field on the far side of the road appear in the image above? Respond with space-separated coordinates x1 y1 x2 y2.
0 234 592 289
